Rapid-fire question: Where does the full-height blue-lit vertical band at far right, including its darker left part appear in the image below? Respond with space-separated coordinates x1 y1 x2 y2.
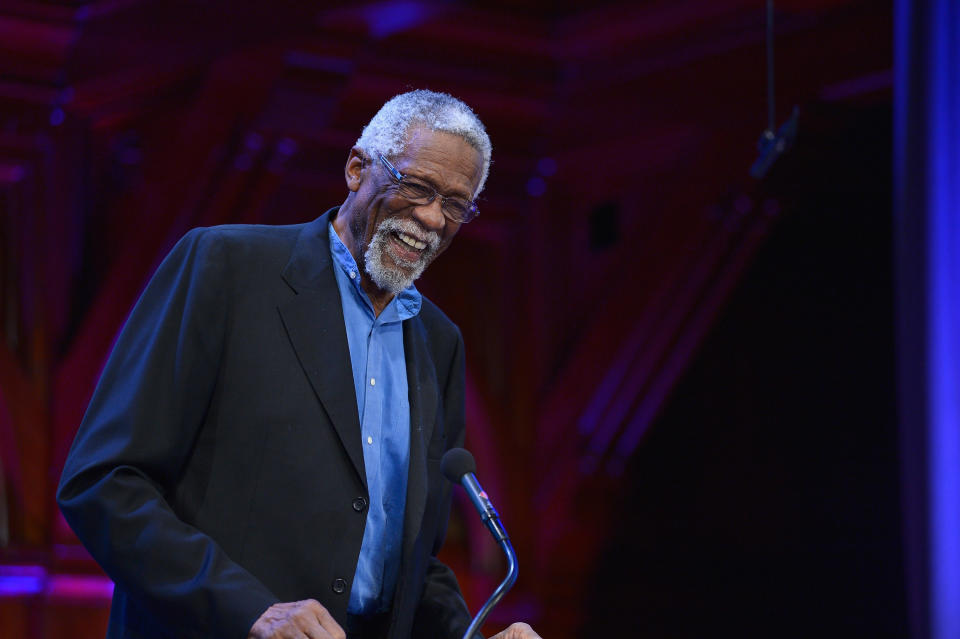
894 0 960 639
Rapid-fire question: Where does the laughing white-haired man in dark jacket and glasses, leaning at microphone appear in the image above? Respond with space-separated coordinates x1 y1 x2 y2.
57 91 537 639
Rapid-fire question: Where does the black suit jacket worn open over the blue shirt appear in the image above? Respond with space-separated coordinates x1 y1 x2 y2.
57 209 469 639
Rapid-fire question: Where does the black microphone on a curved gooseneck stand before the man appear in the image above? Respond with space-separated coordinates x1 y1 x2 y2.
440 448 519 639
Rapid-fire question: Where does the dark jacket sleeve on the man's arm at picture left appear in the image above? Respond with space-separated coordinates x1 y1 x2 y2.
57 229 277 639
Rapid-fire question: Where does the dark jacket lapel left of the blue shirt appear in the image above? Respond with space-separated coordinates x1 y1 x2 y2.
279 210 367 486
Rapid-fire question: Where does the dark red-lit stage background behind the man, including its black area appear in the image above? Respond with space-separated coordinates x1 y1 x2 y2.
0 0 908 639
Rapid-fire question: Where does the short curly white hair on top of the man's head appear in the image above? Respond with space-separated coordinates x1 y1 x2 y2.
357 89 493 197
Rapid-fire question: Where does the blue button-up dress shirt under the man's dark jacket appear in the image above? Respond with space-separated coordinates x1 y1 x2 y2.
329 224 421 614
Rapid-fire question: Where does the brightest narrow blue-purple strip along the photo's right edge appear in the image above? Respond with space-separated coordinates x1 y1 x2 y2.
927 0 960 639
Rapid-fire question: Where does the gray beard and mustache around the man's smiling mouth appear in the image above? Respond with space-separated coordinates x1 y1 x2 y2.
363 217 440 295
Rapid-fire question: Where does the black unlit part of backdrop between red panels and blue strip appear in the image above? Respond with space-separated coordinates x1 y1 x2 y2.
581 104 908 638
